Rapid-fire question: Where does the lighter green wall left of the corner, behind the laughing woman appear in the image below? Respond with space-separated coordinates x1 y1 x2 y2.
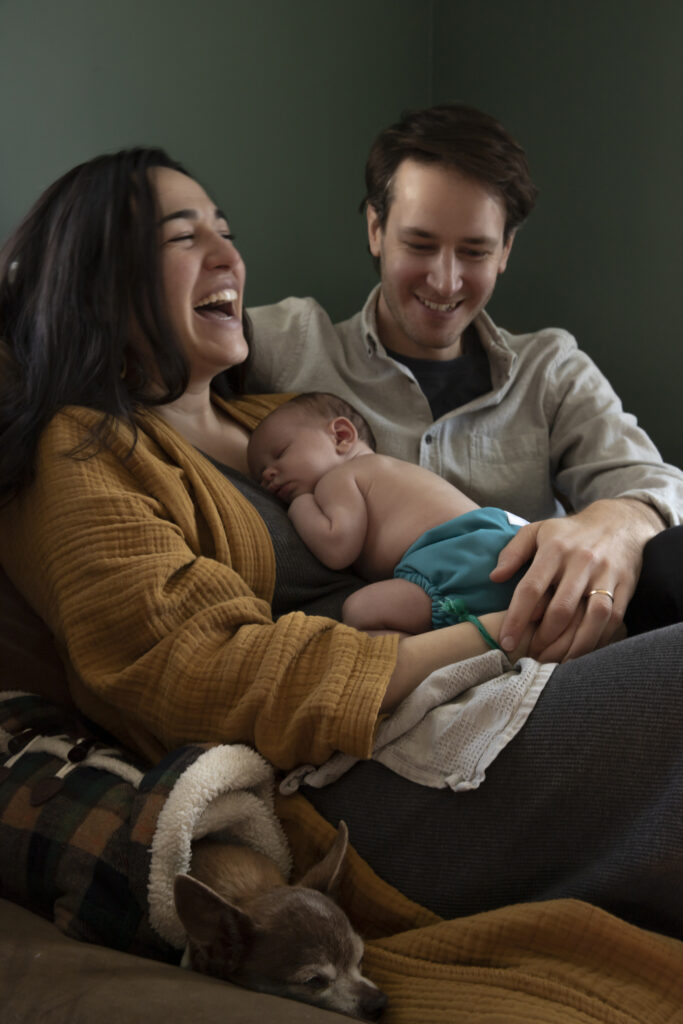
0 0 430 316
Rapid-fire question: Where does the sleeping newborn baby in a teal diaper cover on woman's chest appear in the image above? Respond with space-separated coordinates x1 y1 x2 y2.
249 392 525 647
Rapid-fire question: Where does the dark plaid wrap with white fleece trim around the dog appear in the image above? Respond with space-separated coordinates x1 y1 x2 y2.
0 692 291 963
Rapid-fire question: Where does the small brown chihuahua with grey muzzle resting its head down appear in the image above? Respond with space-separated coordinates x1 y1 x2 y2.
175 821 387 1021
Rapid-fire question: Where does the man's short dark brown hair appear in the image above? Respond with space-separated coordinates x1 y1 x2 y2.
361 103 538 242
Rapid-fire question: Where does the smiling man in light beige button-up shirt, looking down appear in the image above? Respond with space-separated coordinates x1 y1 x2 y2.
248 104 683 660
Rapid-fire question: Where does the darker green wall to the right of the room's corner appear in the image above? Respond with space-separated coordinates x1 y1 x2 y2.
433 0 683 466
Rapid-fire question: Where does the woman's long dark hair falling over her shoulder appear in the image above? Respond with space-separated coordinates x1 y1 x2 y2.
0 147 242 502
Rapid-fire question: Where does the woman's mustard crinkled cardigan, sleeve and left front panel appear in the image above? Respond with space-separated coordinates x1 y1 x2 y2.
0 411 397 769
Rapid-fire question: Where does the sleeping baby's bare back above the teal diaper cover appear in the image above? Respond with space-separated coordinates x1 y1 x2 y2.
346 455 478 580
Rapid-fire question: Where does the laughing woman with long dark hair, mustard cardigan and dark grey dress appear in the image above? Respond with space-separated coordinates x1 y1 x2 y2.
0 150 683 935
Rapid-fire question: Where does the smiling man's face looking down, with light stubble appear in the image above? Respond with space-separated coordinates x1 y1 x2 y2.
368 160 512 359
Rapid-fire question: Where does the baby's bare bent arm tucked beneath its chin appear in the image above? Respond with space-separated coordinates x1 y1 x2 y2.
289 470 368 569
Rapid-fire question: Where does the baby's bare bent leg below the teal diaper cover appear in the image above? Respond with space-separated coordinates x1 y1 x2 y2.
342 579 432 633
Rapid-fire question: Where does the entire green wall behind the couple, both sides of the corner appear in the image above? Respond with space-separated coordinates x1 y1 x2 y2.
0 0 683 465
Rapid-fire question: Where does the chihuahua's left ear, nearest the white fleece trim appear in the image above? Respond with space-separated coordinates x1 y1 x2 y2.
173 874 254 978
